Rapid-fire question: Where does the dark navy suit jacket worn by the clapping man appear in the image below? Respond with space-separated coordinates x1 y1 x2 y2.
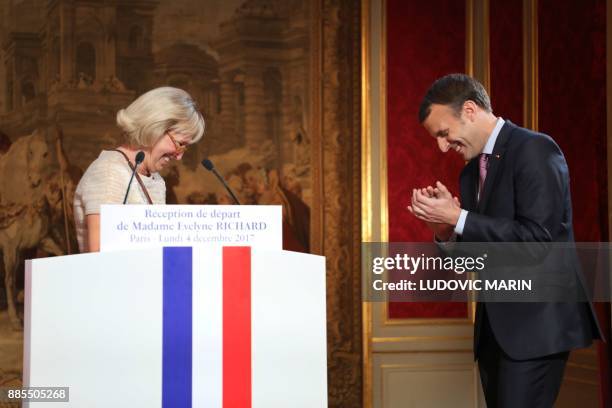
460 121 600 360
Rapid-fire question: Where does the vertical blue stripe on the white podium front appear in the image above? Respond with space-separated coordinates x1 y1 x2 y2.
162 247 192 408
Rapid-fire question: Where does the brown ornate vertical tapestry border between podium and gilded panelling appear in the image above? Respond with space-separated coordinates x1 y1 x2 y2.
312 0 362 408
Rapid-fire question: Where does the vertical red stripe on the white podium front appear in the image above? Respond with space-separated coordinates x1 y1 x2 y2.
223 247 251 408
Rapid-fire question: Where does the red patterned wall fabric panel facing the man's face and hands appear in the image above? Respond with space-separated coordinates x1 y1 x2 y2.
387 0 467 318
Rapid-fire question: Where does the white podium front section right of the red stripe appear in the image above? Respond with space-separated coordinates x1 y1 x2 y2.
251 249 327 408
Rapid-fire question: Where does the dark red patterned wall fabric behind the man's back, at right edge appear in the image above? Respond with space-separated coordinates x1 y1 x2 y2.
538 0 612 400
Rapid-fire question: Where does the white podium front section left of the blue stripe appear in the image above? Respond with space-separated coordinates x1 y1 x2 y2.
26 249 163 408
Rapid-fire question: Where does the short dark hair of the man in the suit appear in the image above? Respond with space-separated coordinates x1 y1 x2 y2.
419 74 492 123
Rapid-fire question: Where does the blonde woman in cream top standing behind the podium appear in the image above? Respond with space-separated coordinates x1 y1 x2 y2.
74 87 204 252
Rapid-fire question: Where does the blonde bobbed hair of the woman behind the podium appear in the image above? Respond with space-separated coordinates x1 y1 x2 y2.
117 86 204 147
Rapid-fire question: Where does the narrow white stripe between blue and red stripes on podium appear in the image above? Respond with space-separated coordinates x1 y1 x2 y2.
192 247 223 408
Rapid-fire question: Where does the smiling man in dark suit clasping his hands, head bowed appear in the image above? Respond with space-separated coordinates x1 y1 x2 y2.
408 74 600 408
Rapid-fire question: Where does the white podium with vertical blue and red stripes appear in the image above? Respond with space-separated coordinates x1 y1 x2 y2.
24 207 327 408
